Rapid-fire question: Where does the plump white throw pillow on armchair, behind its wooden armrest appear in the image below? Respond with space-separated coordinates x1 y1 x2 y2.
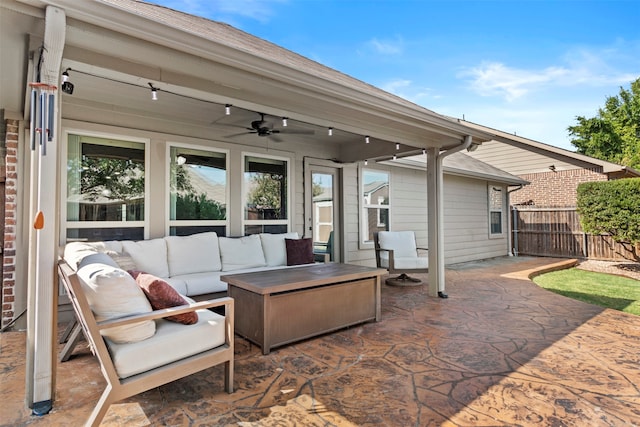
78 263 156 343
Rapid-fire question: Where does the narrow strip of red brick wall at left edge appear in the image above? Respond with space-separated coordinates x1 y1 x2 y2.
2 120 20 327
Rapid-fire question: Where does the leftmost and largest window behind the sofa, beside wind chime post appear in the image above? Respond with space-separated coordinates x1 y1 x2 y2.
66 134 146 241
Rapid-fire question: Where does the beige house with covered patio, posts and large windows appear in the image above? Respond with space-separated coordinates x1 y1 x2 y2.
0 0 526 414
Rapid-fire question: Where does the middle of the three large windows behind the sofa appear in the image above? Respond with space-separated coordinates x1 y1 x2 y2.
169 147 227 236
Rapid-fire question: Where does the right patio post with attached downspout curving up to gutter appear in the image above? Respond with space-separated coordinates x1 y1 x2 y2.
427 135 473 298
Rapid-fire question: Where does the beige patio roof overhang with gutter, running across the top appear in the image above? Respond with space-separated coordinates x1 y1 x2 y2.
13 0 492 162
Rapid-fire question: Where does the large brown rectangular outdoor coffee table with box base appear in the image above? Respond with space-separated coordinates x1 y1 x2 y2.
220 263 387 354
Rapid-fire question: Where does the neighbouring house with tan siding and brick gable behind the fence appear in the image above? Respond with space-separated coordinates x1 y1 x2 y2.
461 121 640 208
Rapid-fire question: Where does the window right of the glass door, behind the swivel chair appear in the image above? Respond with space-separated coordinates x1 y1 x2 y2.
360 169 389 243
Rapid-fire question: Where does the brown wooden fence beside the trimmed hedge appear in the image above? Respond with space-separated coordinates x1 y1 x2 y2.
511 206 637 261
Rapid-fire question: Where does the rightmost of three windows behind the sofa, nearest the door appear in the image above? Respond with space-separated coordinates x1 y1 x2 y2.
243 156 289 234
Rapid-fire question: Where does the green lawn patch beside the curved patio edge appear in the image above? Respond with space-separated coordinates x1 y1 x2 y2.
533 268 640 316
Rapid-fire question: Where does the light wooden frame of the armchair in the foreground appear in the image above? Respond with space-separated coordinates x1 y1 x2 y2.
58 260 234 426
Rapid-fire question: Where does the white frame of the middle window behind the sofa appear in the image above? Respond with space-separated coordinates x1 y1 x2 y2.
165 141 232 236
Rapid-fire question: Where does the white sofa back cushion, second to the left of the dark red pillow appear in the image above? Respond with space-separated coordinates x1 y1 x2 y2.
218 234 266 271
